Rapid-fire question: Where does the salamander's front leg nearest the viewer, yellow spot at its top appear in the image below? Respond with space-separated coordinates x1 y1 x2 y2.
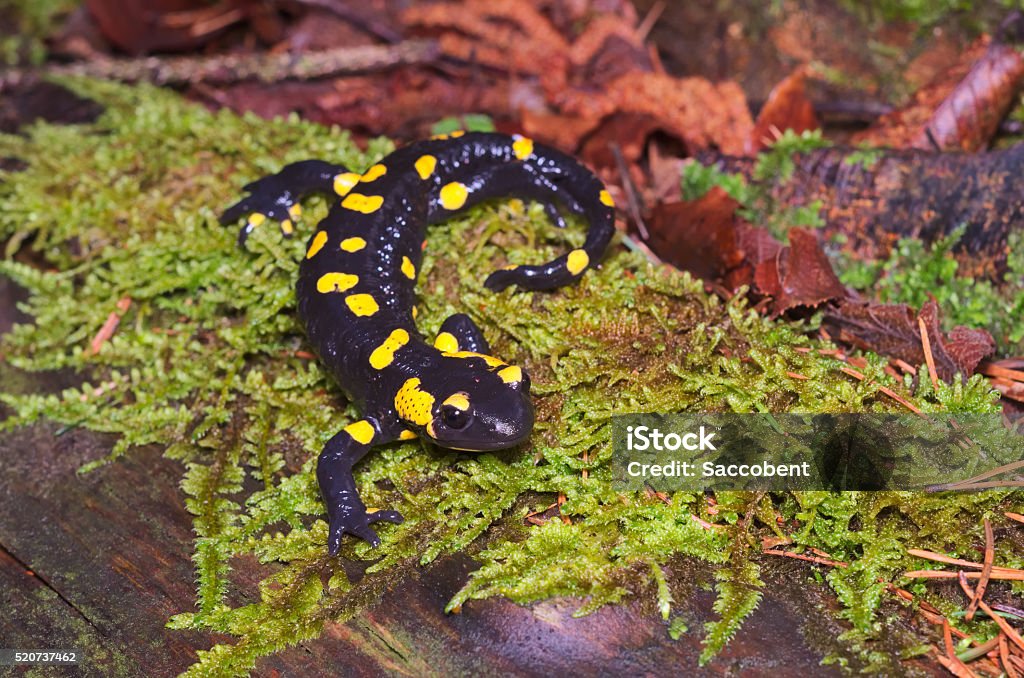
316 419 402 555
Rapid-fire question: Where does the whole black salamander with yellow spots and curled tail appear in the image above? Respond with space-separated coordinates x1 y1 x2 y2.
221 132 614 555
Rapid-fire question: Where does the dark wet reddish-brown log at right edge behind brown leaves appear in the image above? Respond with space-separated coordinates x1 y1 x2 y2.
698 143 1024 280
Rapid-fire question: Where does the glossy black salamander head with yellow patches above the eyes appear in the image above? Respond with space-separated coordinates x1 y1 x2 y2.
395 353 534 452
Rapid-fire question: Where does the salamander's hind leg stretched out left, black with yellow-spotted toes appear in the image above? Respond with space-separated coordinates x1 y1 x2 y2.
220 160 358 246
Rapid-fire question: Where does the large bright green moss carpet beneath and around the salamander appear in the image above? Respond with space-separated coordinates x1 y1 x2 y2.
0 81 1020 675
